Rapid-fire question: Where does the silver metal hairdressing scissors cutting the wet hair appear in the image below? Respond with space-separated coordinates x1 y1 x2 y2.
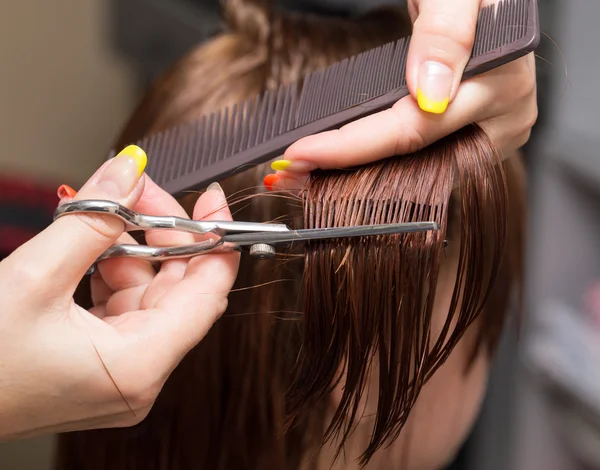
54 199 440 274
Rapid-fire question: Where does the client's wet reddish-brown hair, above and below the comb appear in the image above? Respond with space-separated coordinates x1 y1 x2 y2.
57 0 524 470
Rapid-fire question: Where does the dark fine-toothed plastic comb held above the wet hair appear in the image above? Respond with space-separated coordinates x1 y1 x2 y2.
116 0 540 196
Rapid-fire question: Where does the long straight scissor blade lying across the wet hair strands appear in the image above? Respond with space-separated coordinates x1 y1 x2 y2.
223 222 440 246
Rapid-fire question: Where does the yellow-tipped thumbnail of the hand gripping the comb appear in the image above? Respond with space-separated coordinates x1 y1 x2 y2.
417 61 454 114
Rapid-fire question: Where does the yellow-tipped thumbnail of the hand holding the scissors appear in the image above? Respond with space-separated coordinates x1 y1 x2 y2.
98 145 148 198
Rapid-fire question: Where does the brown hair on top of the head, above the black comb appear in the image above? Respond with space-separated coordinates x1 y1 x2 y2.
116 0 410 147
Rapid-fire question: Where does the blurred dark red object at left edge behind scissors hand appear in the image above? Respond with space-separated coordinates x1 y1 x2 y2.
0 175 58 258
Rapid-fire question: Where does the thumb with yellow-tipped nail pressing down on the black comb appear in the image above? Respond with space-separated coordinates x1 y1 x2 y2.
406 0 481 114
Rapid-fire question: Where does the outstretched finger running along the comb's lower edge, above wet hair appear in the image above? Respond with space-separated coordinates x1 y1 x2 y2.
282 49 537 173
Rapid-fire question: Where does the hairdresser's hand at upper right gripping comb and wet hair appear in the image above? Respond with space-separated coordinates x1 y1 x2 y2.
272 0 537 185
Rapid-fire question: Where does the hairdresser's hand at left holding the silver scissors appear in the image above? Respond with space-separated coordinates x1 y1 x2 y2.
0 147 238 439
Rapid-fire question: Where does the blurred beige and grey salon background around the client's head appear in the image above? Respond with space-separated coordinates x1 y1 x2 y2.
0 0 600 470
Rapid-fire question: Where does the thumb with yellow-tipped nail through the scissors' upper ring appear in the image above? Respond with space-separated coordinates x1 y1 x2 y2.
15 145 147 292
